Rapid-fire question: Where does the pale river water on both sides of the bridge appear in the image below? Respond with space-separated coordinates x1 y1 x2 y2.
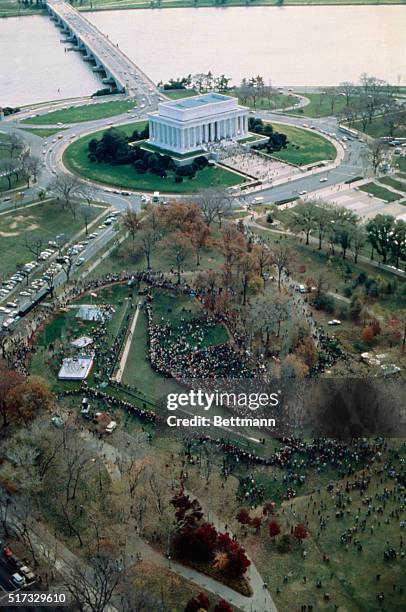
0 6 406 106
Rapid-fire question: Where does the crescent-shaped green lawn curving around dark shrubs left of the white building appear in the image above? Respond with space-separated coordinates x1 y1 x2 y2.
63 122 243 193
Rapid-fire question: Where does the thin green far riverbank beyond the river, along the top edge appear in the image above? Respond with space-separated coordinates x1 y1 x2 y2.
0 0 406 18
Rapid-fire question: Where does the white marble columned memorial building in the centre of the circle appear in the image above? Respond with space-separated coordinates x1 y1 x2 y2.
148 93 248 155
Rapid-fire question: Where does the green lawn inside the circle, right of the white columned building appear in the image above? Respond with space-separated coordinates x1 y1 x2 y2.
264 122 337 166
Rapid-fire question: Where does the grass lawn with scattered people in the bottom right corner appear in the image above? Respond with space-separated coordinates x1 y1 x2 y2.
239 442 405 612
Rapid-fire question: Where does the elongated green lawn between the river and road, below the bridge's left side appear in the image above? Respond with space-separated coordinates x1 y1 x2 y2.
21 100 135 125
